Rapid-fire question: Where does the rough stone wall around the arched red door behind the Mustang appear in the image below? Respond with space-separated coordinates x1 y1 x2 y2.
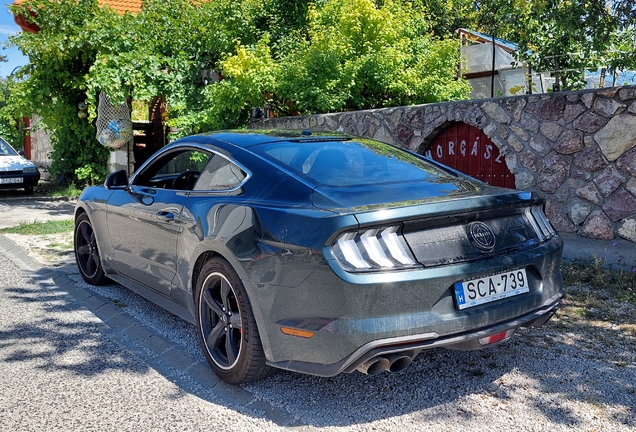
250 86 636 242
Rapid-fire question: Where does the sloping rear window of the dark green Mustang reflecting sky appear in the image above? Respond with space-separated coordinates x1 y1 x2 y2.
252 139 441 186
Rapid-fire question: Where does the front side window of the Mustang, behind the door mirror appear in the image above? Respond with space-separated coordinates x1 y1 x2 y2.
135 150 211 190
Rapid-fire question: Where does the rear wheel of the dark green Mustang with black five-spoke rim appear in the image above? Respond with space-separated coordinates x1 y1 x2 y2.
195 258 274 384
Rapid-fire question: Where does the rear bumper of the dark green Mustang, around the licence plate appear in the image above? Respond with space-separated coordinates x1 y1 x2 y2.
250 236 564 376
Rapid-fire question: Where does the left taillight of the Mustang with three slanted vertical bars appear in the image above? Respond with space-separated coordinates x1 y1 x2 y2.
333 226 420 272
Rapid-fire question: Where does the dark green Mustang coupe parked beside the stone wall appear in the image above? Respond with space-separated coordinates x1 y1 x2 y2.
75 131 564 383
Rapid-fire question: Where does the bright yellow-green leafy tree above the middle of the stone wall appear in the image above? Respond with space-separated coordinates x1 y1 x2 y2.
276 0 468 112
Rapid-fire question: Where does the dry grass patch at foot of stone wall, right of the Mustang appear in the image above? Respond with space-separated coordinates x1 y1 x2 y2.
561 259 636 304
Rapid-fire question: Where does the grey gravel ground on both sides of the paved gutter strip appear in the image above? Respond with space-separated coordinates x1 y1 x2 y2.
0 233 636 431
